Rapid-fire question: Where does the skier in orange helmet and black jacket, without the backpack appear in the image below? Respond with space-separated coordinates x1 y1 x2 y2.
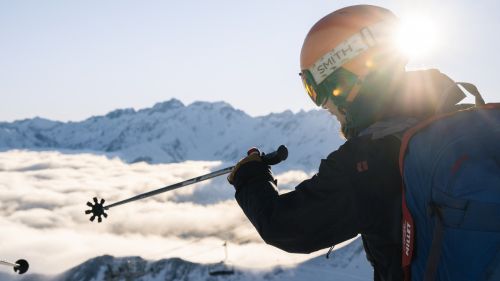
228 5 476 281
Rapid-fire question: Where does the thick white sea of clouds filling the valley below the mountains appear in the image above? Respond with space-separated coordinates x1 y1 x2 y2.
0 150 322 274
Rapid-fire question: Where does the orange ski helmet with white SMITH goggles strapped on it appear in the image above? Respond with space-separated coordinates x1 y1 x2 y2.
300 5 406 110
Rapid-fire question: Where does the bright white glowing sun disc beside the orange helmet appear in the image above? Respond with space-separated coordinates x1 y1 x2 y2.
396 16 438 59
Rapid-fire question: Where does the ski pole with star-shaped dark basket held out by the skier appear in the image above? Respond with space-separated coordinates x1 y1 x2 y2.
85 145 288 222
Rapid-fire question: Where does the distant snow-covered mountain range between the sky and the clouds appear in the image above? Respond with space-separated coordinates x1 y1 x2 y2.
0 99 343 169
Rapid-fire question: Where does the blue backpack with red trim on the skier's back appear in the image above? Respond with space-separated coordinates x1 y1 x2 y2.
400 93 500 281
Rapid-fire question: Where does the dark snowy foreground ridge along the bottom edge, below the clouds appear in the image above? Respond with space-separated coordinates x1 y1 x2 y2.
0 238 373 281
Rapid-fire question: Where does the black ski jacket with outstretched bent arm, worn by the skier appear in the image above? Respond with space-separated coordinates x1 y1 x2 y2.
234 135 403 281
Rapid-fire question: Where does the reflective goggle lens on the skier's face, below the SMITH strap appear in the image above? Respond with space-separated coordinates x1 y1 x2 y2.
300 67 361 107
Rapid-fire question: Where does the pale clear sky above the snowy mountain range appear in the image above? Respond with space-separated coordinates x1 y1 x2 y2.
0 0 500 121
